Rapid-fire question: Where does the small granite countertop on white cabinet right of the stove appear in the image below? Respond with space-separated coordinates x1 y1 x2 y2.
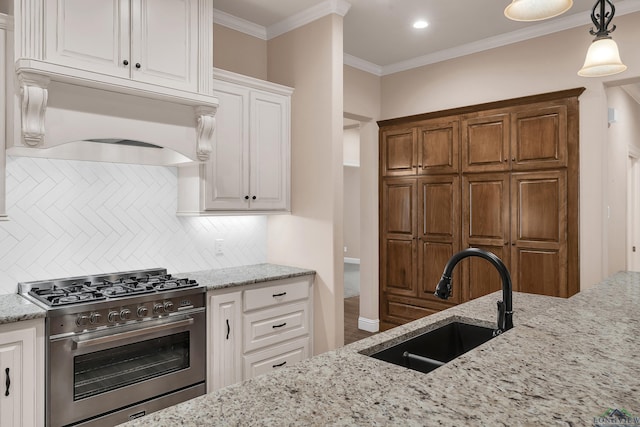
175 264 315 291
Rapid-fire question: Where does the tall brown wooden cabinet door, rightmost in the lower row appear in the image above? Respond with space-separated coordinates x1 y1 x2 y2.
511 171 569 297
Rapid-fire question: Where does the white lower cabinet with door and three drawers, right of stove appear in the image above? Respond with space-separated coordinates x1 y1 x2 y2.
207 276 313 391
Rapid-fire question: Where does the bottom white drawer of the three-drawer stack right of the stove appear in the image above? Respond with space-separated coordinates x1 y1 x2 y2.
244 337 309 380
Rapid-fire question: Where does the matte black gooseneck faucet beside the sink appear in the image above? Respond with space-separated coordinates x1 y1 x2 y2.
434 248 513 336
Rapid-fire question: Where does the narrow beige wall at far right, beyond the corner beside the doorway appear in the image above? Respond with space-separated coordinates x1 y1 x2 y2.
604 87 640 275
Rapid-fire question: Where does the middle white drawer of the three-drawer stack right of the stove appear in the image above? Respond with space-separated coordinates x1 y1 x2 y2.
243 301 309 352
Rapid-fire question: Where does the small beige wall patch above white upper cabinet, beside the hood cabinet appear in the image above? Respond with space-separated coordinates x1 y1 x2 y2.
213 24 267 80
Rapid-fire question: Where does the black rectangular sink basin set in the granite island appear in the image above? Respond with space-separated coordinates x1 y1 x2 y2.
364 322 493 373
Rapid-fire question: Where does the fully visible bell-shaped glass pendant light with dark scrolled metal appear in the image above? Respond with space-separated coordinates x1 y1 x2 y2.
578 0 627 77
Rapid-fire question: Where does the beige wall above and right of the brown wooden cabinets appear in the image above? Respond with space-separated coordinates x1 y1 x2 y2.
382 13 640 289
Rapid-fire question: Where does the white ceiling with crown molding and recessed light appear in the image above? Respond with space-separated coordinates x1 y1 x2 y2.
213 0 640 75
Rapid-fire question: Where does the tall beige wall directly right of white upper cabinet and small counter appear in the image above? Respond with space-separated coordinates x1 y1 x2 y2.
267 15 344 354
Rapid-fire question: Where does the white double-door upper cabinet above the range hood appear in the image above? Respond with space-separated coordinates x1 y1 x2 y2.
44 0 198 91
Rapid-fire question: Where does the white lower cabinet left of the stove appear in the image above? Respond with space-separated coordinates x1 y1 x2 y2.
0 320 44 427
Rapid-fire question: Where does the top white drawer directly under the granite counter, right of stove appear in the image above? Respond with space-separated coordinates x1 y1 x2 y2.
244 277 309 311
